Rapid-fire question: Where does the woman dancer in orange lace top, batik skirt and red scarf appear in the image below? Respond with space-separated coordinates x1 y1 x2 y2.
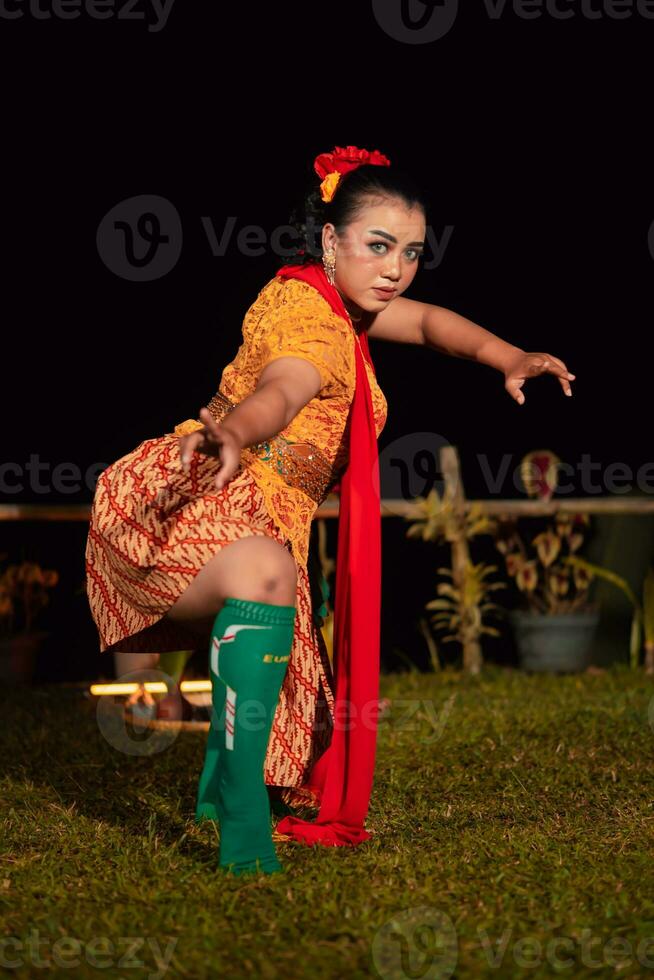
86 146 574 874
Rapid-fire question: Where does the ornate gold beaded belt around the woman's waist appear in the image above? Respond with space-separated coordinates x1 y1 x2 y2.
207 391 340 504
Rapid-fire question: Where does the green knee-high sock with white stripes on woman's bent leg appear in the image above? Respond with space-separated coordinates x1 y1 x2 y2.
196 597 296 874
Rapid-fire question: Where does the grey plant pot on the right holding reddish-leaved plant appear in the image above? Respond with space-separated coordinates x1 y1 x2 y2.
509 609 599 673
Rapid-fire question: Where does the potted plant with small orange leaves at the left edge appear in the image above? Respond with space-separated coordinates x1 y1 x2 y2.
0 555 59 684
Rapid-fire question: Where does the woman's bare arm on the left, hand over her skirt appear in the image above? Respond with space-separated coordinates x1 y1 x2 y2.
179 356 322 489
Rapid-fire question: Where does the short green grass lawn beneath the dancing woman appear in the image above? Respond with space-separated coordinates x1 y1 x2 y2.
0 666 654 980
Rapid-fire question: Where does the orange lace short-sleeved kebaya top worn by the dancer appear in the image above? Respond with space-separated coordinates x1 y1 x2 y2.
174 276 388 567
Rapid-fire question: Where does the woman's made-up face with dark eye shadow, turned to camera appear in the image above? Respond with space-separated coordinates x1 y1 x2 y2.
322 199 426 316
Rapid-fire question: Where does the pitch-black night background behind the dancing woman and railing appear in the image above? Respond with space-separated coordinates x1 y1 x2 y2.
0 0 654 680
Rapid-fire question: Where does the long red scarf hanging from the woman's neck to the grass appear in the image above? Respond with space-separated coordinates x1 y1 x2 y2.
277 262 381 846
